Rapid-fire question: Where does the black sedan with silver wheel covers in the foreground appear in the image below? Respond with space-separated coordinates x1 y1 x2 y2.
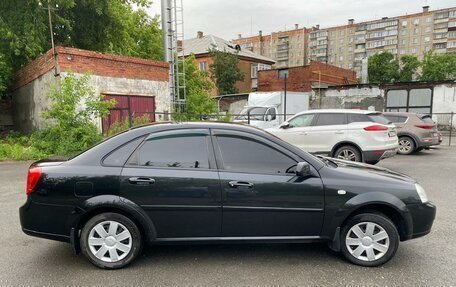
20 123 436 269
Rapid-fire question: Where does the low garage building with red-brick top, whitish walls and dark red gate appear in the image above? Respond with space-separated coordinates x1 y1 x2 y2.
9 47 170 133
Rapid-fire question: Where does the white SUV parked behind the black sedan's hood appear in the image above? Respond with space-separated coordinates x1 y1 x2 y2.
266 110 398 164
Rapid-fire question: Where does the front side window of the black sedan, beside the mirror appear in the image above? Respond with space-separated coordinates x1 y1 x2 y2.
217 136 296 174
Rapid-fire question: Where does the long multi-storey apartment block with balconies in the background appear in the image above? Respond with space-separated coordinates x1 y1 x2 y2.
234 6 456 79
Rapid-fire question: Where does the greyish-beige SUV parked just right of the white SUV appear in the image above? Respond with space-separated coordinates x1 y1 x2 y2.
383 112 442 154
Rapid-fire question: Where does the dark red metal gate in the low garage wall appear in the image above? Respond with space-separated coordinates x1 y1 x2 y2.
102 95 155 133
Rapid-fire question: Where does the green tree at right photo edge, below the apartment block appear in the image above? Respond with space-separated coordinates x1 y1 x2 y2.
420 50 456 81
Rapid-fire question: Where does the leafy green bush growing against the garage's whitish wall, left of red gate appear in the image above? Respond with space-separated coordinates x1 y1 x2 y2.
33 74 115 155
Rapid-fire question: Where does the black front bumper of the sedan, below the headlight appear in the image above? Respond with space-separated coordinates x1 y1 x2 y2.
405 202 437 240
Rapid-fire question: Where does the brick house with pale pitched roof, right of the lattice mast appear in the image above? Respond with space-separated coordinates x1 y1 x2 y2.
183 32 275 96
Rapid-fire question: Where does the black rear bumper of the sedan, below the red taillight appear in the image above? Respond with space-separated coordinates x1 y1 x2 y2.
19 198 72 242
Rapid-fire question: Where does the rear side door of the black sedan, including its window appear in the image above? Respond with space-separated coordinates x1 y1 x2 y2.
120 129 221 238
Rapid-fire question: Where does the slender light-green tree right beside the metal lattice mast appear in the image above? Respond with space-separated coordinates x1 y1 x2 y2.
174 55 217 121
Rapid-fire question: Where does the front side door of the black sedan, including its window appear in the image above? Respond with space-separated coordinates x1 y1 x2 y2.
212 130 324 237
